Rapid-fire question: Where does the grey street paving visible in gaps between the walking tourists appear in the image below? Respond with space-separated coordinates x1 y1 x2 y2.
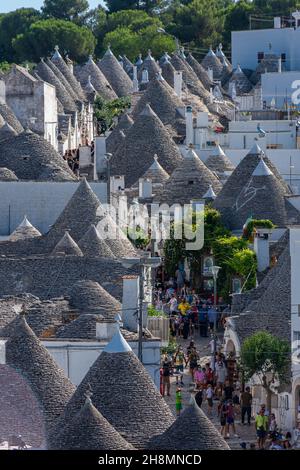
165 331 256 450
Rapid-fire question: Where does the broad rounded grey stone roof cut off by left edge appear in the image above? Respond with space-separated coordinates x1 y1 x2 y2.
0 131 76 181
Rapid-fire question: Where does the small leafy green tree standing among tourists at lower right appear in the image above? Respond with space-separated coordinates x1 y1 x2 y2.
241 331 290 411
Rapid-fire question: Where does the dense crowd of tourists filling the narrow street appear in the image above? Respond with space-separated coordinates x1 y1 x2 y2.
154 278 291 450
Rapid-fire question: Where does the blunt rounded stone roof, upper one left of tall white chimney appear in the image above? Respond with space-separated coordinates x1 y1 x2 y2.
69 280 121 320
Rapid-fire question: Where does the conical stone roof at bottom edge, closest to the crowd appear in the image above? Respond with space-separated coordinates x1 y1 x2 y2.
148 401 229 451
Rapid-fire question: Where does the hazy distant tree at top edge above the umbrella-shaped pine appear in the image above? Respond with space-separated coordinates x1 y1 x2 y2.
42 0 89 22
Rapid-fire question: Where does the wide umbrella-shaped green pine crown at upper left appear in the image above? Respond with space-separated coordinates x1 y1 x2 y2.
13 19 96 62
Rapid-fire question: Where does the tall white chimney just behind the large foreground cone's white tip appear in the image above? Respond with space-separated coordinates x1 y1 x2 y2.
122 276 139 332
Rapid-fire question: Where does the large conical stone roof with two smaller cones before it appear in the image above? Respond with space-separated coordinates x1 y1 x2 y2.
46 179 135 257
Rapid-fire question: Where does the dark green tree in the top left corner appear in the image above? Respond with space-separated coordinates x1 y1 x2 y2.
0 8 41 62
